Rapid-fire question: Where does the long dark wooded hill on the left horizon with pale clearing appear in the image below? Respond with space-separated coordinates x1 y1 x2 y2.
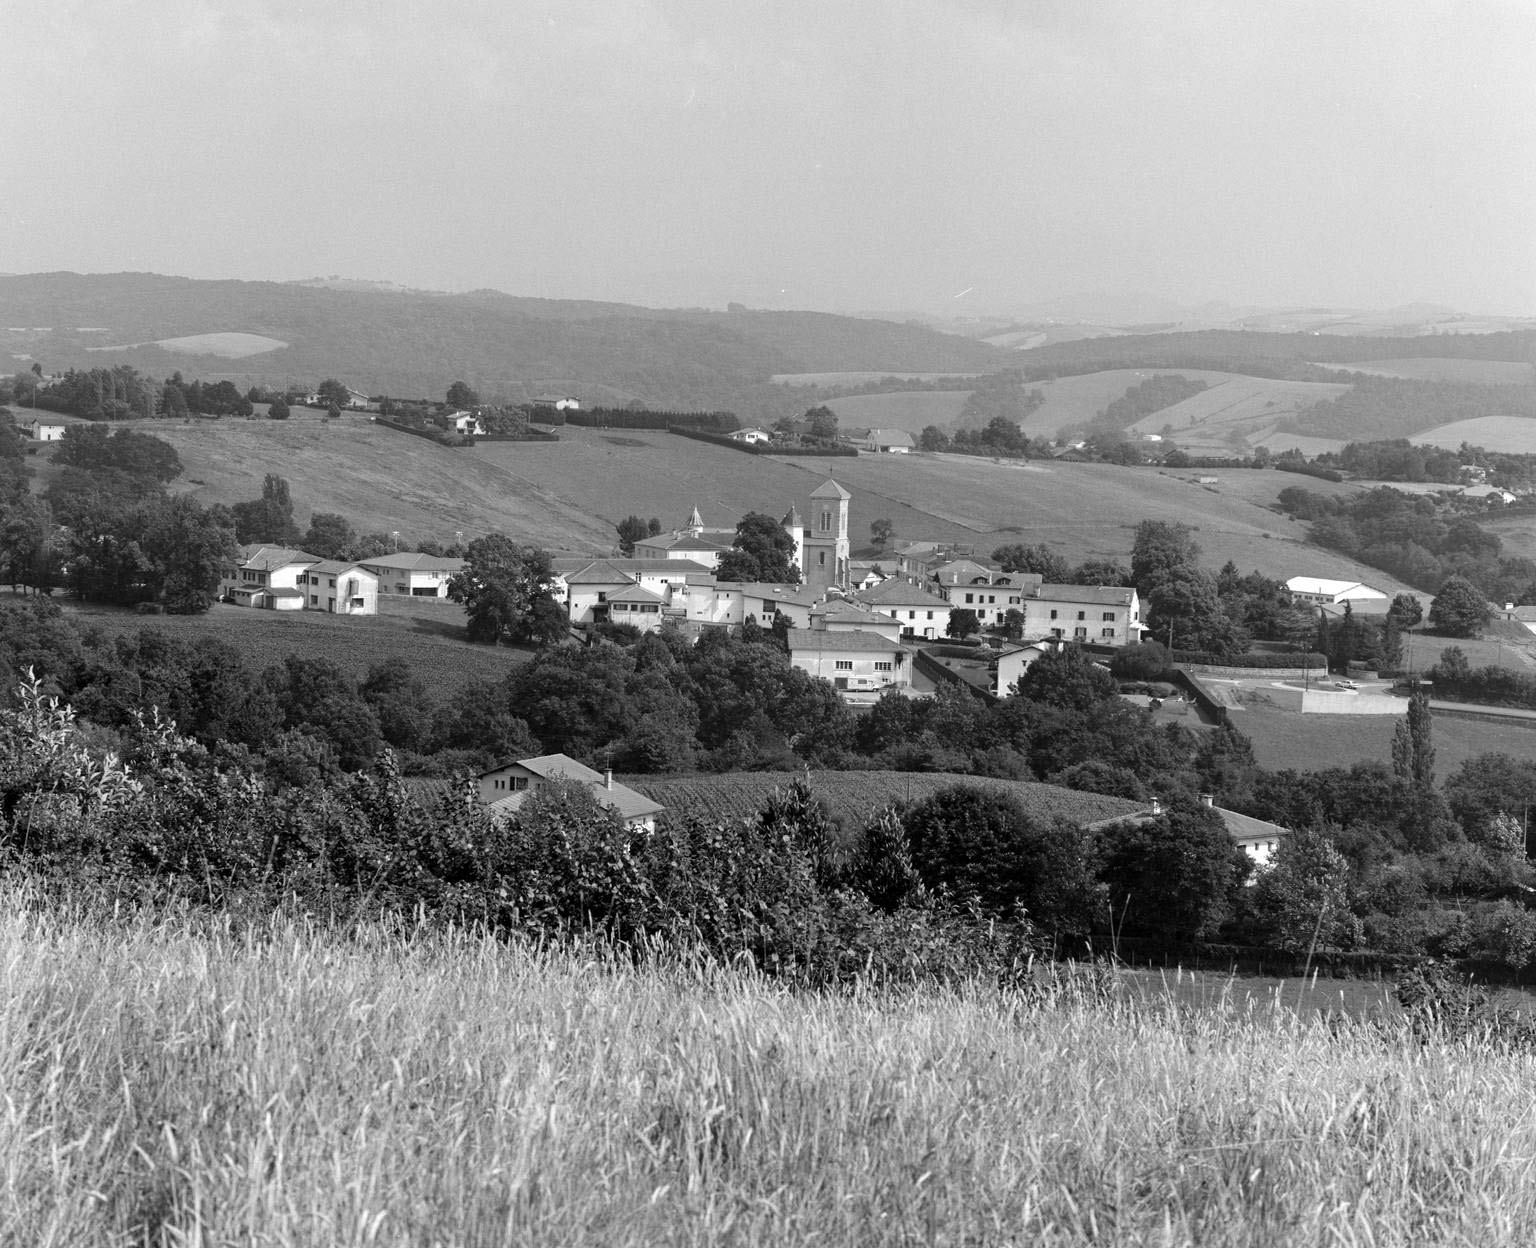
0 274 1006 418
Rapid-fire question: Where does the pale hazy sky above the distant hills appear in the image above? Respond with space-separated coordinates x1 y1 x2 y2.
9 0 1536 314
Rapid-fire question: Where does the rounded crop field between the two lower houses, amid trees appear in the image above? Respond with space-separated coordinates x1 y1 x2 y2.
624 772 1143 835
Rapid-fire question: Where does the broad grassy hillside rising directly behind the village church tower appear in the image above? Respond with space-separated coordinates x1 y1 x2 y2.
132 405 1401 590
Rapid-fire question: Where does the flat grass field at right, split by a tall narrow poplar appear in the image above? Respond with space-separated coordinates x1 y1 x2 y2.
1232 705 1536 779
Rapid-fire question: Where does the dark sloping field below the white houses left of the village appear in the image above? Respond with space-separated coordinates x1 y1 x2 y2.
63 598 531 693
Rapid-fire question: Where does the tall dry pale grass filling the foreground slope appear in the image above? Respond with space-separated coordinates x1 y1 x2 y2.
0 890 1536 1248
